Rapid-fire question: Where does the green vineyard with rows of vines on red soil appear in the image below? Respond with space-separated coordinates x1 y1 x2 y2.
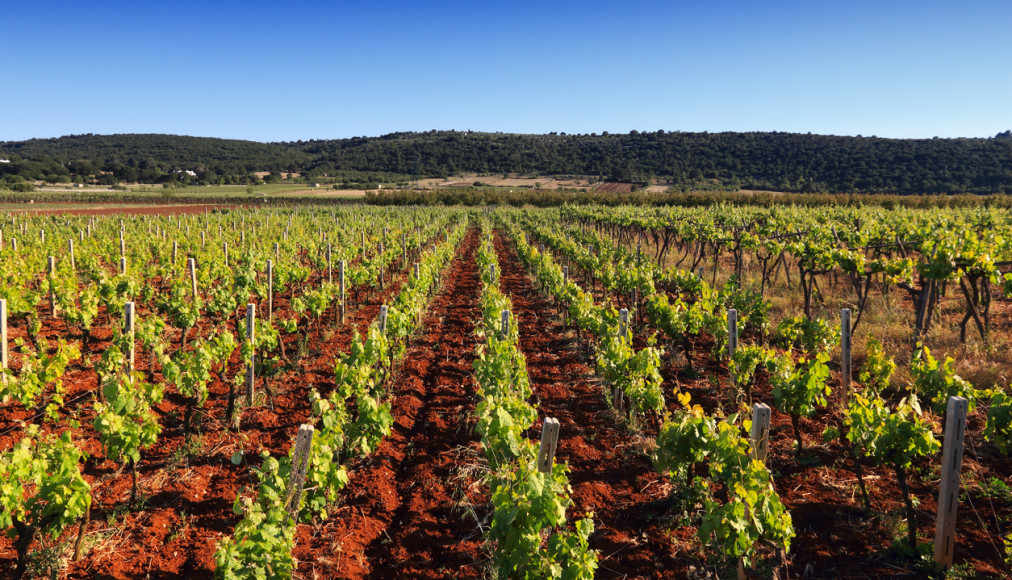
0 205 1012 580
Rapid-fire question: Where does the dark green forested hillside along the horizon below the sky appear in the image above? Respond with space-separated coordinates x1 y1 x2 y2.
0 131 1012 193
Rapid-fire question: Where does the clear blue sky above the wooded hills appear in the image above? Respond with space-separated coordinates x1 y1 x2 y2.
0 0 1012 141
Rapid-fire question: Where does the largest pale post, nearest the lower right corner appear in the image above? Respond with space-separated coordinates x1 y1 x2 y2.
934 397 967 568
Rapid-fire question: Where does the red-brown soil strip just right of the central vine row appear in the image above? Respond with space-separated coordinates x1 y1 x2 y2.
495 232 688 578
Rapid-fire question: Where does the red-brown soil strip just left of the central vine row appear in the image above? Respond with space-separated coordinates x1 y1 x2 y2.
294 230 484 578
